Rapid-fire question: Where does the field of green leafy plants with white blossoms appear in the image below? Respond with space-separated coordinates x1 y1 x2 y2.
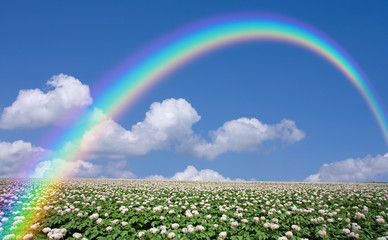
0 179 388 240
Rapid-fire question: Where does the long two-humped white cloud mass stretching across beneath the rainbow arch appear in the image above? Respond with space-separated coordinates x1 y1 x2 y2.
77 99 305 159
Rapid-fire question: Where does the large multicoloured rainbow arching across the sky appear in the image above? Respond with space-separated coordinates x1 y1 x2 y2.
3 13 388 238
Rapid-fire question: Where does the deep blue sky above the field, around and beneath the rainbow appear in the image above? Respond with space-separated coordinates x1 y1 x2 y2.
0 1 388 181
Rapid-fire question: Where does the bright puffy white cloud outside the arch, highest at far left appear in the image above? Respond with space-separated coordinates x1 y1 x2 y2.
0 74 92 129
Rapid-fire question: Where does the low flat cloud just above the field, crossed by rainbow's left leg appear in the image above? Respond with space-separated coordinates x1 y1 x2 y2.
32 159 136 179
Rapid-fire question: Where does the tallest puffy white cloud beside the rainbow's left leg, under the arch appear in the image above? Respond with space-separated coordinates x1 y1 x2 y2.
81 99 200 158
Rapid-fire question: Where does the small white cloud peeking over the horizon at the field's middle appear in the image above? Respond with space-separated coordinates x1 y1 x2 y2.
146 166 231 181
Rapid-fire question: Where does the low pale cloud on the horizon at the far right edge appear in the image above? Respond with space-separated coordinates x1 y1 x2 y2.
305 153 388 182
